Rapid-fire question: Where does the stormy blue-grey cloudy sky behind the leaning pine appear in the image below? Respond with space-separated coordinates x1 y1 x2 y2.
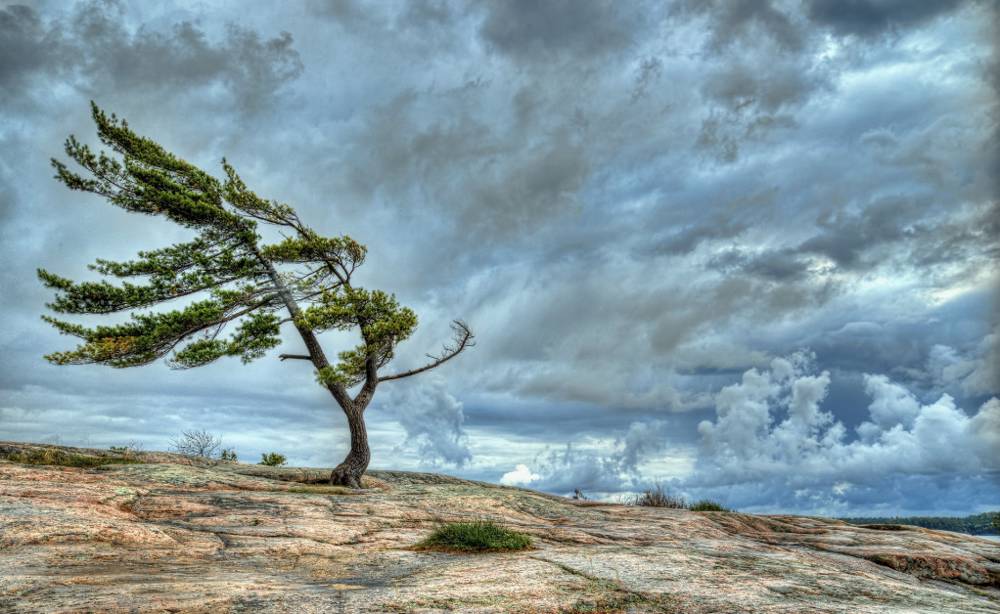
0 0 1000 516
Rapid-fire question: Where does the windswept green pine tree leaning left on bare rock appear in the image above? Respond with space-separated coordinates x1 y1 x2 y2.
38 103 473 487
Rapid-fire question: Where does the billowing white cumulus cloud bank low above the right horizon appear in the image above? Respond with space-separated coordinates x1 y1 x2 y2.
684 354 1000 513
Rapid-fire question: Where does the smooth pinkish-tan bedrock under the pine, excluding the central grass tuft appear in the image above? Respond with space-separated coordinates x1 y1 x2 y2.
0 443 1000 613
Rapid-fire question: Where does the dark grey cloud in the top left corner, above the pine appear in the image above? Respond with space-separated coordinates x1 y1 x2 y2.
0 1 302 110
